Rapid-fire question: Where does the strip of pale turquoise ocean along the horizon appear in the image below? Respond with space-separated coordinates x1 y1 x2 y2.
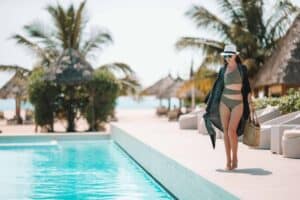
0 96 179 111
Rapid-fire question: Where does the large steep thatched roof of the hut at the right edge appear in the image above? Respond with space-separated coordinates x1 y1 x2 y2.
253 15 300 96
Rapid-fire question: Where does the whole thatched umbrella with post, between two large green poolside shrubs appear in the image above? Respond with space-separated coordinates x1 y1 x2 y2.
45 48 95 132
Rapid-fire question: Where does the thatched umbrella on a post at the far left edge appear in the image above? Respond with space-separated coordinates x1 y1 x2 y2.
0 71 28 124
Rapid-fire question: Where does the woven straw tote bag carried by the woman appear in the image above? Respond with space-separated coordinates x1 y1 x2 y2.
243 111 260 147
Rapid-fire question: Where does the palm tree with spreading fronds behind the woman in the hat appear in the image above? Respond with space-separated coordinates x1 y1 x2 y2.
176 0 299 76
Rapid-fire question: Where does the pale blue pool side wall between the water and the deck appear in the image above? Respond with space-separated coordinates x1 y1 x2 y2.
111 124 238 200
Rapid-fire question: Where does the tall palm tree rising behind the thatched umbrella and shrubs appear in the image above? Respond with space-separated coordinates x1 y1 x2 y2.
7 1 136 130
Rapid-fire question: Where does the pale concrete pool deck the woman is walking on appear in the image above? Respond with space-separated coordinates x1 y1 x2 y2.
112 110 300 200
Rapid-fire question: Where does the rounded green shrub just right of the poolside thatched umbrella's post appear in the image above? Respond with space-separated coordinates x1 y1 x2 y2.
86 70 120 130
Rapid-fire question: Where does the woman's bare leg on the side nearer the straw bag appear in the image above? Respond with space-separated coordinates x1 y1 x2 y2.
228 103 244 169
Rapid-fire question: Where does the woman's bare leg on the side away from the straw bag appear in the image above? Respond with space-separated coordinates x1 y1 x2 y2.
220 102 231 170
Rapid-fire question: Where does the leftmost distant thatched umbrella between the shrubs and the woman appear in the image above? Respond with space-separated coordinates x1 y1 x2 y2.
142 74 174 109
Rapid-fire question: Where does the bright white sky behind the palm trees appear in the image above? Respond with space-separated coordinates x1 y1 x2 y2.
0 0 300 87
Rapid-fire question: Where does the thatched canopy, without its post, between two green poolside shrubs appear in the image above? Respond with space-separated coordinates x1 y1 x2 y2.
45 49 94 85
